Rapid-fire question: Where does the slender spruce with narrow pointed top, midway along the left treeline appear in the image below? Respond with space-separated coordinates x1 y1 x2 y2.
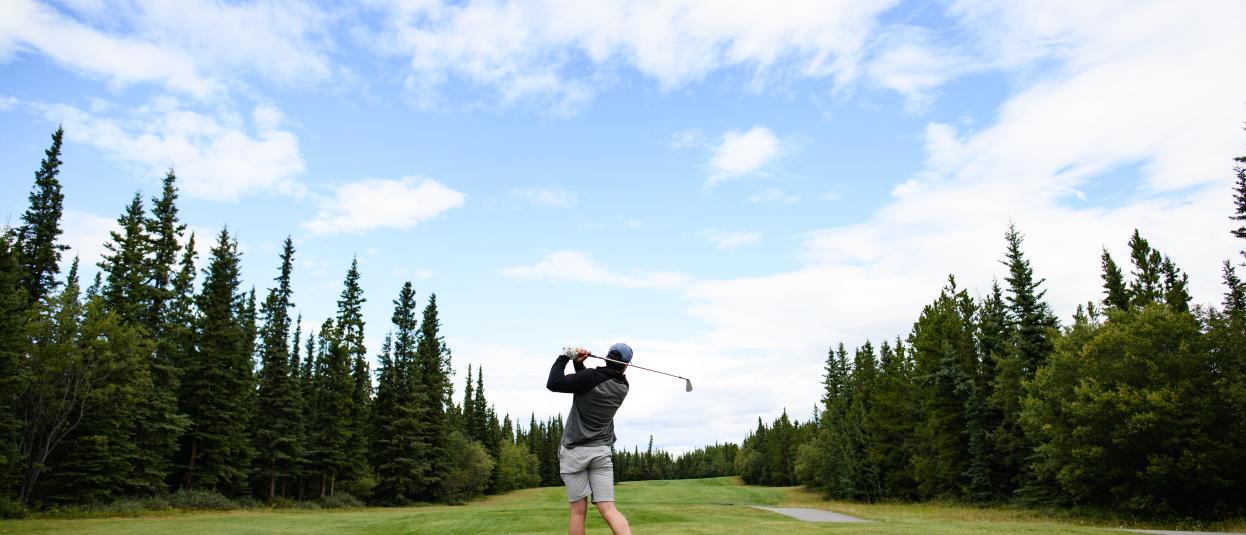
255 237 303 503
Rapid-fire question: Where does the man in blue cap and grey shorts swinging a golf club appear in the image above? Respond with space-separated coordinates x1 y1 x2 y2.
546 344 632 535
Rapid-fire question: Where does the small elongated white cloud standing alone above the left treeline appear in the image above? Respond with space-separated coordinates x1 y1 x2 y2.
304 177 467 234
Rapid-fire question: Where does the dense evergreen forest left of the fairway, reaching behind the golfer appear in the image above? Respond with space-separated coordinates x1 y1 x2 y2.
0 128 734 516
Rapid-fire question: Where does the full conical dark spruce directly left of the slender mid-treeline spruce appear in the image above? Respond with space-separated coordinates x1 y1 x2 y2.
181 229 254 495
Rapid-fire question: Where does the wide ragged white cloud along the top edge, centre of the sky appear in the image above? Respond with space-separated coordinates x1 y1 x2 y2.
368 0 893 113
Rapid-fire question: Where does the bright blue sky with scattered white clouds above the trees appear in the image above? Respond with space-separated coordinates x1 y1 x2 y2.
0 0 1246 450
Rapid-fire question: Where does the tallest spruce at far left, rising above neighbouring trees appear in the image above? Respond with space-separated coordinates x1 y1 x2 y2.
17 126 69 304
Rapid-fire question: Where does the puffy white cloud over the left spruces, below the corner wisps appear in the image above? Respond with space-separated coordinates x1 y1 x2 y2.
39 99 304 201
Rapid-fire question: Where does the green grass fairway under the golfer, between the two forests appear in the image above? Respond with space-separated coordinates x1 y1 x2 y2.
0 478 1246 535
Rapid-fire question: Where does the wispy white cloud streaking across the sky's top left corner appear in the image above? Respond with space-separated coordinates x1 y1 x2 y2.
0 0 333 100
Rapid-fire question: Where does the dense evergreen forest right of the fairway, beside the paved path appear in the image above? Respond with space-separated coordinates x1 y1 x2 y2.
735 144 1246 516
